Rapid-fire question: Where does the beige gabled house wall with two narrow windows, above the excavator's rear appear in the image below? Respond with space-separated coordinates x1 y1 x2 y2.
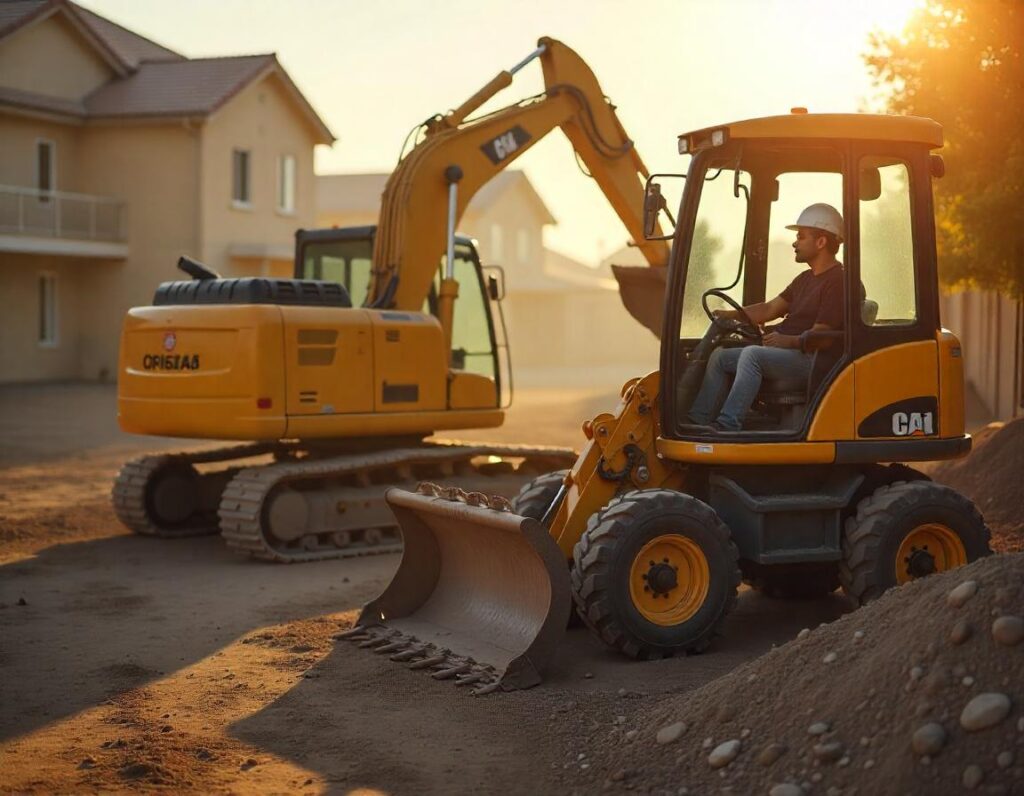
199 75 316 276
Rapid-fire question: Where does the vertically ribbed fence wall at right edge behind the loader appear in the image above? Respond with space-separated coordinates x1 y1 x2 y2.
941 291 1024 421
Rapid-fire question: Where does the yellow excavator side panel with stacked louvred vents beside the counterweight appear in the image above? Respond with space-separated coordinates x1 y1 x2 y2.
281 306 374 416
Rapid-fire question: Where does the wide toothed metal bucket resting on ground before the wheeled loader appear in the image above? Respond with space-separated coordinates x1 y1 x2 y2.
346 485 571 693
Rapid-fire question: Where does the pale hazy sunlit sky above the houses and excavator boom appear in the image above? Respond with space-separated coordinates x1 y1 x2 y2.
76 0 919 264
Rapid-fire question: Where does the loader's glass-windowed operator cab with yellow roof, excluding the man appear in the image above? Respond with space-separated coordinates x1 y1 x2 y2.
662 115 941 442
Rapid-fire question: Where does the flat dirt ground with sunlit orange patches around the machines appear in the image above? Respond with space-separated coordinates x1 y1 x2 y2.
0 385 1019 794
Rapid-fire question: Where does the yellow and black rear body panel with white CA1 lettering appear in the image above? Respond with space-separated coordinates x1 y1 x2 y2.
854 340 945 438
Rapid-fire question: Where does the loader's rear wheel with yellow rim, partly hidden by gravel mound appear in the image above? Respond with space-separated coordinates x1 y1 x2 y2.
840 480 992 603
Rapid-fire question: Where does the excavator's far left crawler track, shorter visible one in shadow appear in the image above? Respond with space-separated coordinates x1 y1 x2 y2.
111 444 281 539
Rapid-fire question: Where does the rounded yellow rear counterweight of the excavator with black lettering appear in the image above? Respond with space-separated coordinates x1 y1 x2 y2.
118 304 285 439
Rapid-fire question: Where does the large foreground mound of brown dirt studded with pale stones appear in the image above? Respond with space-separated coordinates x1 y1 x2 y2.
589 554 1024 796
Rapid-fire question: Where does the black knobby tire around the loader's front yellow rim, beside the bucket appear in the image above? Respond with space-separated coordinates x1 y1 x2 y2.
571 490 740 659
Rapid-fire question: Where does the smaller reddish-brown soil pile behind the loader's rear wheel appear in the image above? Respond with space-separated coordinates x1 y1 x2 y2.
929 417 1024 552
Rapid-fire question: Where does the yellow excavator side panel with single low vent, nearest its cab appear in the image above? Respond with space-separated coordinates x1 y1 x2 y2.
368 311 449 412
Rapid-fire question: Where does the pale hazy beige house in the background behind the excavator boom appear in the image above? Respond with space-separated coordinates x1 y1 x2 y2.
316 170 658 383
